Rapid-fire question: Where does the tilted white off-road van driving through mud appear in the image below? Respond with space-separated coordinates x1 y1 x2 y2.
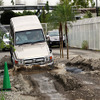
10 15 53 66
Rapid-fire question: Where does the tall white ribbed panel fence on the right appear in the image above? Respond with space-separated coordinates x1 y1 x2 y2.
68 17 100 50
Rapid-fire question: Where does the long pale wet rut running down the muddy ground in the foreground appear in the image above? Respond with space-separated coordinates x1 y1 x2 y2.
32 74 67 100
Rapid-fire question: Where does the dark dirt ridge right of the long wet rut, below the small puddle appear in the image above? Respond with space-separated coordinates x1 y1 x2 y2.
51 64 82 90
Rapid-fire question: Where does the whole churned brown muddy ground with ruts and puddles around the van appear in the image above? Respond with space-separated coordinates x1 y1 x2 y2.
0 56 100 100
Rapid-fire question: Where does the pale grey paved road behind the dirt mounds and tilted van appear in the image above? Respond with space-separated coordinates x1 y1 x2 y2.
0 48 100 59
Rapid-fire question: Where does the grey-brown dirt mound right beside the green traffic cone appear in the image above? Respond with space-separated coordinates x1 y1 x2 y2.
0 74 37 100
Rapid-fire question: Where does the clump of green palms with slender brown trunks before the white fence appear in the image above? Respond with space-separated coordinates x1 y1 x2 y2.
49 0 75 59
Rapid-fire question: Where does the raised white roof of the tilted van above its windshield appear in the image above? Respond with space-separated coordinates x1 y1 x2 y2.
11 15 42 32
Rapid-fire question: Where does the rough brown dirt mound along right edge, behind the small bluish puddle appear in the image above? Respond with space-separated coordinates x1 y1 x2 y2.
66 56 100 70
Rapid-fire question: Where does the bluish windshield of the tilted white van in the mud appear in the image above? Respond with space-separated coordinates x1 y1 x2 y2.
15 29 45 45
